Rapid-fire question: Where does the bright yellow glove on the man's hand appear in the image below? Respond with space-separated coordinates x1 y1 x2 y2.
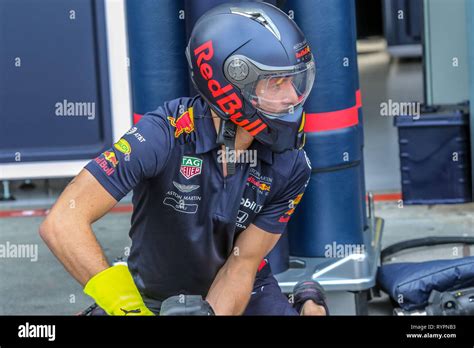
84 265 154 315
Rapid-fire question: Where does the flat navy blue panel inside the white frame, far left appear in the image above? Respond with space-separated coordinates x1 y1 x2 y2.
0 0 112 163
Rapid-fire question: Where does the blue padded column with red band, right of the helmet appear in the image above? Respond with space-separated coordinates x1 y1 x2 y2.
285 0 365 257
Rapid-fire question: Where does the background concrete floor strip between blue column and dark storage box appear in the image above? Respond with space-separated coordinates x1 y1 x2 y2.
359 42 423 192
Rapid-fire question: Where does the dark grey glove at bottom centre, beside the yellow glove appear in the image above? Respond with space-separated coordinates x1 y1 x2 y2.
160 295 215 316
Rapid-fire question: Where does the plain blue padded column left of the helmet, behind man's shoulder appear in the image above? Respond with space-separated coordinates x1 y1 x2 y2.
127 0 189 115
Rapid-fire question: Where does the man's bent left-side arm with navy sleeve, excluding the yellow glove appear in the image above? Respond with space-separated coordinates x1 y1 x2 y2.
40 112 173 285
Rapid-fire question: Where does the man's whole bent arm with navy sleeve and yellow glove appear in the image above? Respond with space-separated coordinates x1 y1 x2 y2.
40 111 177 315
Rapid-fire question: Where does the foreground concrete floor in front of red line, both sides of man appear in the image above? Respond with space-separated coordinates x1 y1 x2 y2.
0 198 474 315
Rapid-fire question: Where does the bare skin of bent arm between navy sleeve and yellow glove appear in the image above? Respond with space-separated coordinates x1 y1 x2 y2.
39 169 117 286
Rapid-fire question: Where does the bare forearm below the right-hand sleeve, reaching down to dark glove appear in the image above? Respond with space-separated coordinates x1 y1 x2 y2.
206 224 281 315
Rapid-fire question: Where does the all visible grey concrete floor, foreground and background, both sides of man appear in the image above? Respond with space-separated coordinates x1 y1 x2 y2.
0 43 474 315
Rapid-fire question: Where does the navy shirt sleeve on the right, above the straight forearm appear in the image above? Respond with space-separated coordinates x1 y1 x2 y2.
253 150 311 234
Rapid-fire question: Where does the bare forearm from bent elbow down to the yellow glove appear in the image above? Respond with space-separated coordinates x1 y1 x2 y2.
40 219 109 286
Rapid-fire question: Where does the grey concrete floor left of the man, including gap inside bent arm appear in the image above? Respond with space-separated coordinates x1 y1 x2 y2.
0 214 130 315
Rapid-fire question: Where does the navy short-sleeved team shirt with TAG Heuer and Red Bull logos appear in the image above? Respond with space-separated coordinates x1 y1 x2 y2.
85 97 311 300
